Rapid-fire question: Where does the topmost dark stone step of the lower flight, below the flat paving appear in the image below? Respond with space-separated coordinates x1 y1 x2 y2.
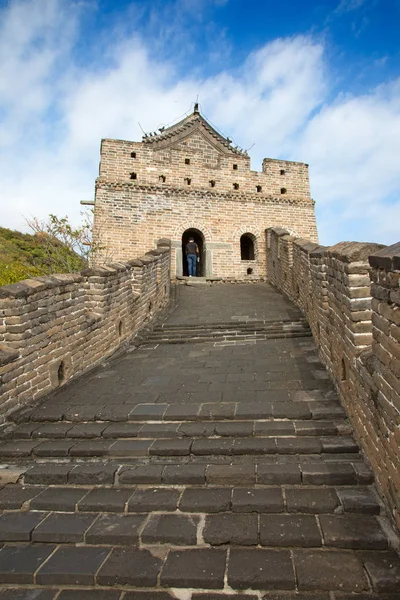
5 400 346 424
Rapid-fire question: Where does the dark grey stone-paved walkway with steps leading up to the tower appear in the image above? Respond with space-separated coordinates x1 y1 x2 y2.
0 284 400 600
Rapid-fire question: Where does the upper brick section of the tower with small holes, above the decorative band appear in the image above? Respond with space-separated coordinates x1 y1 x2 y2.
99 138 310 198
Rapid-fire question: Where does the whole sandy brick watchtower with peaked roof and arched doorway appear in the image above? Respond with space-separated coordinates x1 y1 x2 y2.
94 104 318 280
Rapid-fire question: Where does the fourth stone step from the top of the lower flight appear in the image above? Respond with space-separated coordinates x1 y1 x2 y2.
17 454 374 487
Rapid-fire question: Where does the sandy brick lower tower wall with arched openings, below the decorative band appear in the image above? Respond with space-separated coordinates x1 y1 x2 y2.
95 183 317 279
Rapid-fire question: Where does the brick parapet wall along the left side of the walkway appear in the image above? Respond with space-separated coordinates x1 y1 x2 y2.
0 240 171 419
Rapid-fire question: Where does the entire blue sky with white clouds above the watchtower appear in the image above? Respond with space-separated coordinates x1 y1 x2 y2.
0 0 400 244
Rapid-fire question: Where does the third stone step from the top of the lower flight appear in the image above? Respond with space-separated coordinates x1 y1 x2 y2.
0 436 359 459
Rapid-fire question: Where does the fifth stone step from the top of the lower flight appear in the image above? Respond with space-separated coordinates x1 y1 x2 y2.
0 483 380 512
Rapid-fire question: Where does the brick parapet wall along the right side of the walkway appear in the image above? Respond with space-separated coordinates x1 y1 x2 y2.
267 228 400 528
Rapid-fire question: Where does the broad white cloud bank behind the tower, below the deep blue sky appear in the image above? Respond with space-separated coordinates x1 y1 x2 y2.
0 0 400 248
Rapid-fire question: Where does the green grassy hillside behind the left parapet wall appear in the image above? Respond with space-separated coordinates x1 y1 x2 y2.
0 227 86 286
